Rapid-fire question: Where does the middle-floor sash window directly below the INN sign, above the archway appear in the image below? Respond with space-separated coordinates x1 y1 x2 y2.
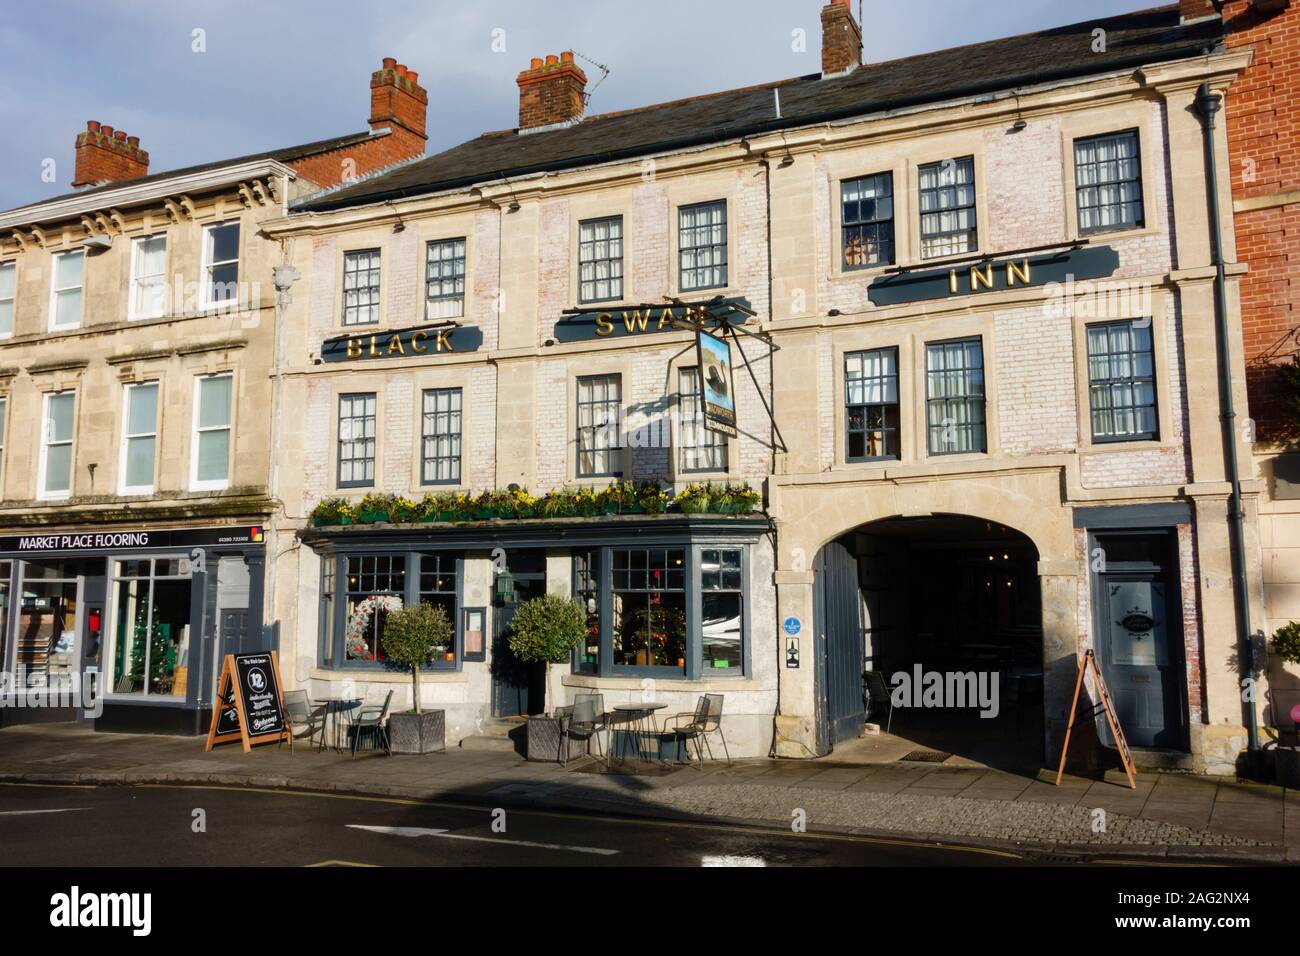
926 338 987 455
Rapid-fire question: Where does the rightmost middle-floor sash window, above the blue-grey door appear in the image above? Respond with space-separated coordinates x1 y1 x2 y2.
1087 319 1158 442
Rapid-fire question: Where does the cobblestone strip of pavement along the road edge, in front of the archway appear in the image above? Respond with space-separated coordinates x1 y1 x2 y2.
624 784 1261 847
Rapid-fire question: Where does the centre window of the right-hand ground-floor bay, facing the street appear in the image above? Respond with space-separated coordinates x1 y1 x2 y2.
611 548 686 674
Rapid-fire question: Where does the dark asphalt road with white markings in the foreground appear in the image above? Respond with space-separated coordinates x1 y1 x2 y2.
0 786 1027 868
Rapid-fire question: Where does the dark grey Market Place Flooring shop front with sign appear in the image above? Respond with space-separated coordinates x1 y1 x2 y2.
0 525 268 734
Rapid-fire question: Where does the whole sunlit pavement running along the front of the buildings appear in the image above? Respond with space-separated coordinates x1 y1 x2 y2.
0 724 1300 864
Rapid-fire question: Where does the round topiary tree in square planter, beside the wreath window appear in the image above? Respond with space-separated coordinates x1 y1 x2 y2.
384 604 455 753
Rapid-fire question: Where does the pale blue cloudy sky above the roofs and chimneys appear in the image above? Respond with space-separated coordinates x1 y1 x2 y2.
0 0 1158 209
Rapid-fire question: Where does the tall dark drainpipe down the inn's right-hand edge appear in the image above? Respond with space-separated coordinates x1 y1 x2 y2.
1196 82 1261 778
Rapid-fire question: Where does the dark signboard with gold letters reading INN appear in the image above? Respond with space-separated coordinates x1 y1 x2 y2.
867 246 1119 306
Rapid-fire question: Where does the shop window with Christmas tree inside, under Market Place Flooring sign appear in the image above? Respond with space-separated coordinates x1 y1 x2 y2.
111 558 191 698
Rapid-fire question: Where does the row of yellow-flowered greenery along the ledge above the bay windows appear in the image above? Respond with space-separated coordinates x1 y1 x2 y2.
311 481 762 527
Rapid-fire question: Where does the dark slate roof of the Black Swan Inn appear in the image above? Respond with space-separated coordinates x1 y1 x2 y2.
293 5 1222 211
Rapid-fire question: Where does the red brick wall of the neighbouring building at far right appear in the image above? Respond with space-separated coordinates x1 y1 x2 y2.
1223 0 1300 438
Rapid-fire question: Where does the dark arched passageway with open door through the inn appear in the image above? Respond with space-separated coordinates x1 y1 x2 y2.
814 515 1044 769
